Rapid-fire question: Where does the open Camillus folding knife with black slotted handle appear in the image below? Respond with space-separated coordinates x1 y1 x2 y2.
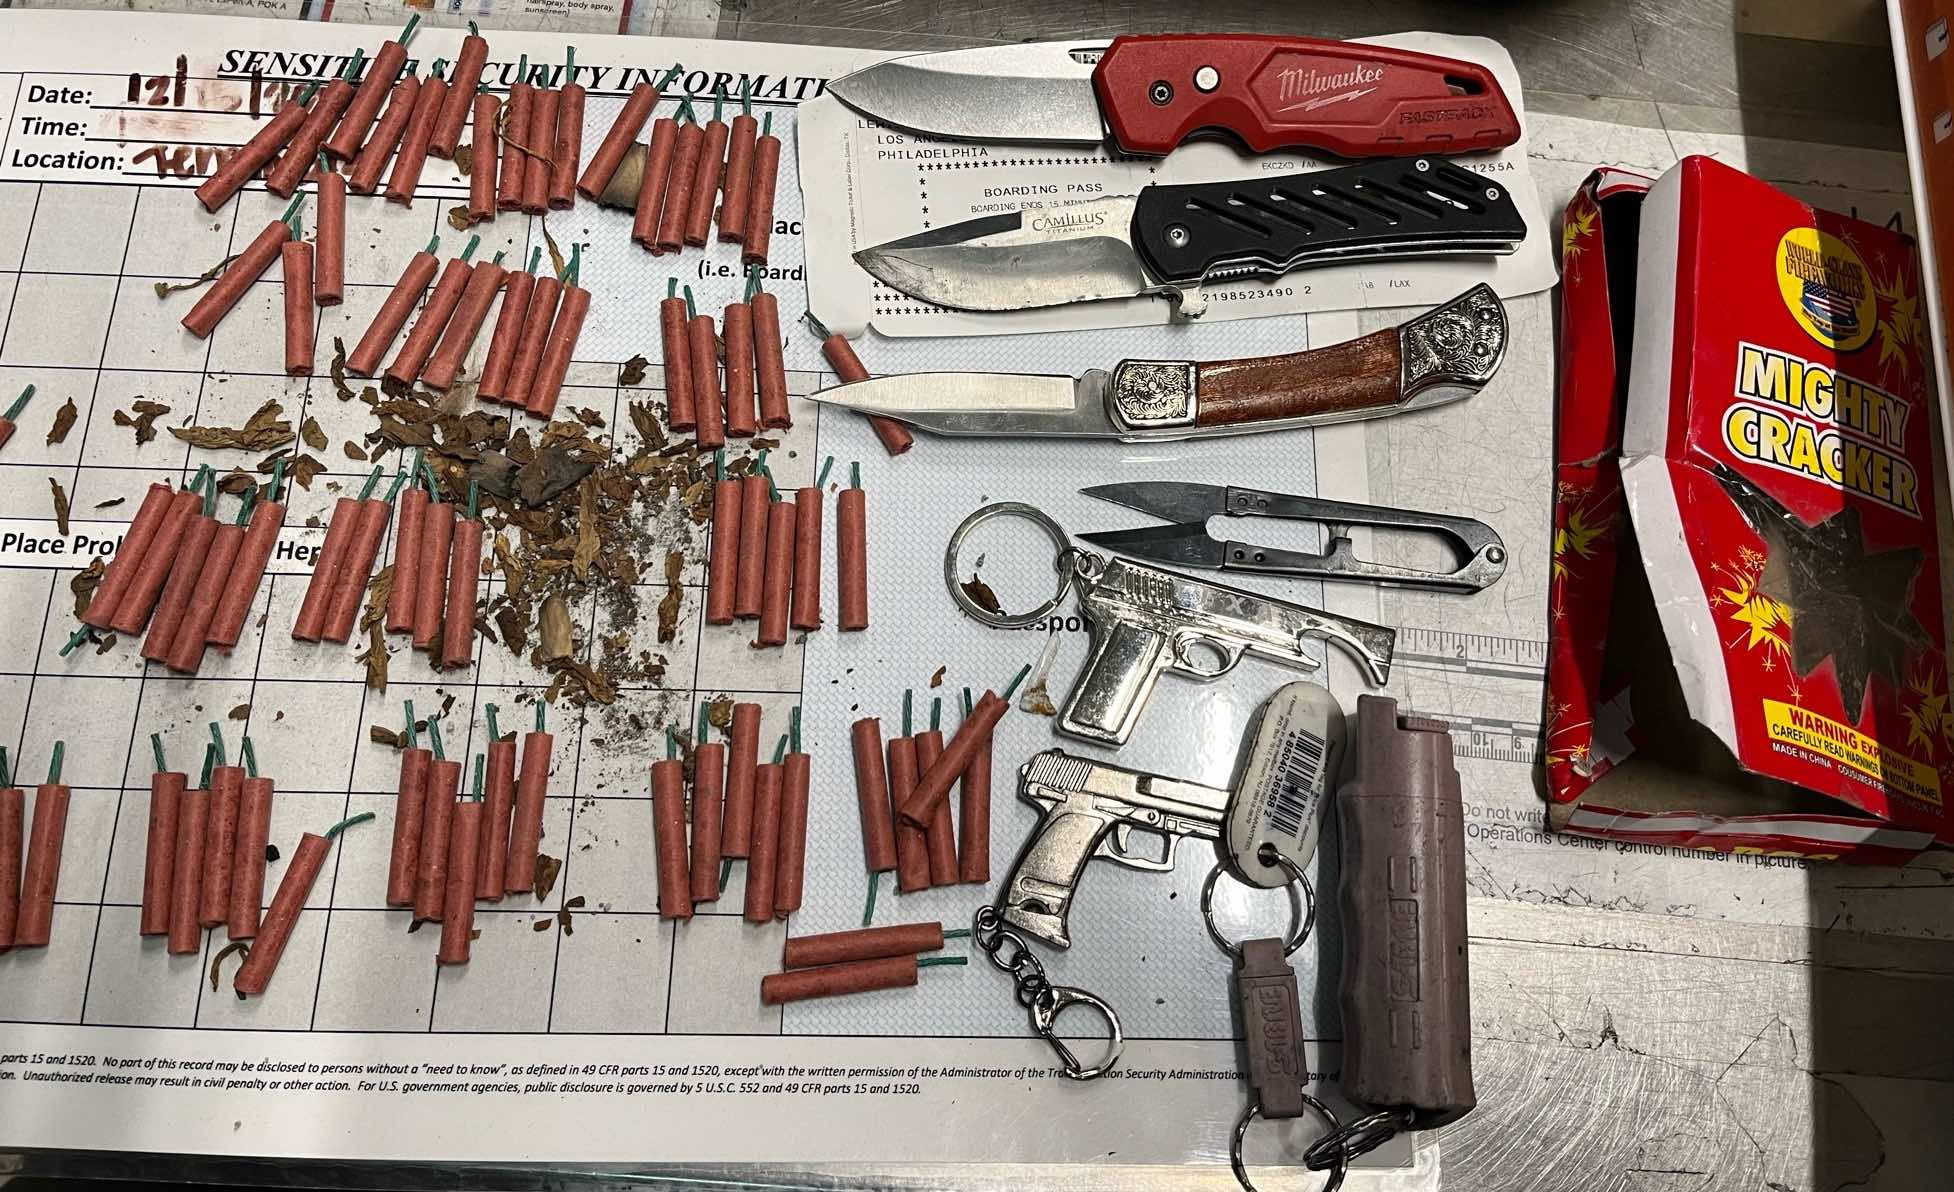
854 156 1526 319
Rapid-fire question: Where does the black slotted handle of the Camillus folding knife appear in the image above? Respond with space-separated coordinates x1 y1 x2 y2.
1131 156 1526 281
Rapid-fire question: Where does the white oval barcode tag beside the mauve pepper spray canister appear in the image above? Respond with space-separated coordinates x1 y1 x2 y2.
1225 682 1344 889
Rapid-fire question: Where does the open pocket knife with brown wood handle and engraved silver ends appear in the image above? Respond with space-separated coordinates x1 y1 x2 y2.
813 283 1507 442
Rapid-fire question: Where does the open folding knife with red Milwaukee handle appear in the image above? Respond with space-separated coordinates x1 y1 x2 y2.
828 33 1520 158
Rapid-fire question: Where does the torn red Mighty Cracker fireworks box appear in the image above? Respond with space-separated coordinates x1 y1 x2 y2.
1546 156 1954 862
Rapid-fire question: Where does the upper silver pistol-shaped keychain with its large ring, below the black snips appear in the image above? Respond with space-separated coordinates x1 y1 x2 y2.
944 500 1397 745
